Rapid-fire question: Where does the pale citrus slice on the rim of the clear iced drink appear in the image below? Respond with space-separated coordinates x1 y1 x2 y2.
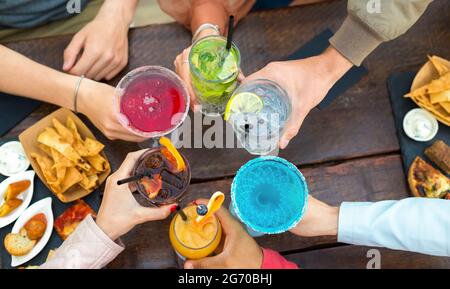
224 92 264 120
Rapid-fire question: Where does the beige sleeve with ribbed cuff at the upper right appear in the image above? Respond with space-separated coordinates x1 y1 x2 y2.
330 0 433 65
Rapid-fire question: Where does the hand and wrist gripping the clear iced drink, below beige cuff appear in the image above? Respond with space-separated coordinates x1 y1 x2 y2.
243 47 353 149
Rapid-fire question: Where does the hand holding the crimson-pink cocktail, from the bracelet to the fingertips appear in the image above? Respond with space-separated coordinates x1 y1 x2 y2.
78 79 145 142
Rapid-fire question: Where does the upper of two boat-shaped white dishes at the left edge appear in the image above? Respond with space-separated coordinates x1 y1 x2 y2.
0 171 36 228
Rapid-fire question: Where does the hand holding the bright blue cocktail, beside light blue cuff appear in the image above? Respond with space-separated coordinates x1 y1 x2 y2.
290 196 339 237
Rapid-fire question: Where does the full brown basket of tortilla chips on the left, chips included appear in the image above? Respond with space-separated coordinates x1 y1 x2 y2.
19 108 111 203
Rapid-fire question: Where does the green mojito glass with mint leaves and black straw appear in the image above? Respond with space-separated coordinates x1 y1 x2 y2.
189 36 241 116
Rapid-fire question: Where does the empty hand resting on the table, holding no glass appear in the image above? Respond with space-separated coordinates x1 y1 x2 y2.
63 1 134 81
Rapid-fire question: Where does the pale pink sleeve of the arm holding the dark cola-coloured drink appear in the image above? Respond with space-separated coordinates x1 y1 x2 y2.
40 215 124 269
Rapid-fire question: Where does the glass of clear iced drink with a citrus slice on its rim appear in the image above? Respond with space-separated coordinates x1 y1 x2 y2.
224 79 292 155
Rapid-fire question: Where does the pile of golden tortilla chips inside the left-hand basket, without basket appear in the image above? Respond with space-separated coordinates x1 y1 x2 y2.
31 116 109 195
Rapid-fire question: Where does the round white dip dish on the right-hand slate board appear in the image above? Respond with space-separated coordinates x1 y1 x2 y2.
403 108 439 142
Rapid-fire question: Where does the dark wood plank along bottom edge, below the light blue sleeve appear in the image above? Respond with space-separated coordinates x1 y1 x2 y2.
285 246 450 269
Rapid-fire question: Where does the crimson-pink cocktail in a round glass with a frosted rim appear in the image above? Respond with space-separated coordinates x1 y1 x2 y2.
114 66 189 138
